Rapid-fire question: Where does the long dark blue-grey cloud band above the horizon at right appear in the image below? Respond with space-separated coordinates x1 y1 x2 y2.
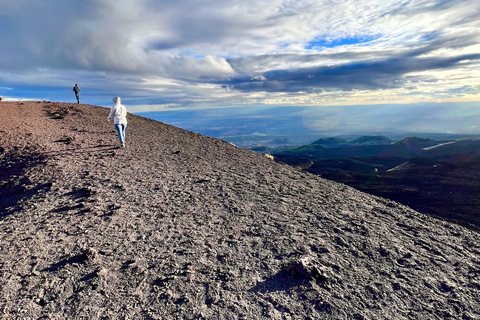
223 50 480 92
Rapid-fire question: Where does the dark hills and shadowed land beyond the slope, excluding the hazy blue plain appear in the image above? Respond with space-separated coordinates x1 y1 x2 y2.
251 136 480 229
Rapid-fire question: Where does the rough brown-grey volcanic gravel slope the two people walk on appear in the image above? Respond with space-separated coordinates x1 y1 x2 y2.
0 102 480 319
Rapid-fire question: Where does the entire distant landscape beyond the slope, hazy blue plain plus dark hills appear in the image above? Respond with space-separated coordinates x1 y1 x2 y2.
137 110 480 228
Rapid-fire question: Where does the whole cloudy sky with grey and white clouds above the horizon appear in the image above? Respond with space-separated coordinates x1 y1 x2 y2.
0 0 480 112
